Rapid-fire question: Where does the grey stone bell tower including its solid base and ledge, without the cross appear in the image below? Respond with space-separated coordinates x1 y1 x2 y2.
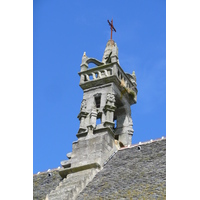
60 40 137 177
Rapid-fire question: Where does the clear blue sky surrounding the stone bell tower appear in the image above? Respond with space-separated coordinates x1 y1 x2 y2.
33 0 166 174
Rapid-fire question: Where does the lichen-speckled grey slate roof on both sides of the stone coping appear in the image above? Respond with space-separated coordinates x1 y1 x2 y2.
33 138 166 200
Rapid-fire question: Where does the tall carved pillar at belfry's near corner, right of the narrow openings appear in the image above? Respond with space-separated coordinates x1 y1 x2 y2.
104 93 116 128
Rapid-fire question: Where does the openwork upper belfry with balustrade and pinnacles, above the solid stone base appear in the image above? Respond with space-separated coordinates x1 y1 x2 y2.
77 37 137 146
